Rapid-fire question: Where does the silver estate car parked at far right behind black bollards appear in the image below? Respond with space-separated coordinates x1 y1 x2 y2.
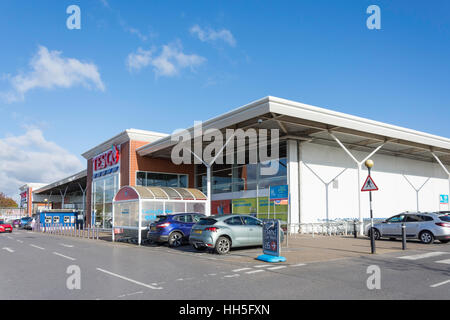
365 212 450 244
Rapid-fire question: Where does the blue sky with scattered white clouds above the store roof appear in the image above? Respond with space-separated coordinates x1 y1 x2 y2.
0 0 450 193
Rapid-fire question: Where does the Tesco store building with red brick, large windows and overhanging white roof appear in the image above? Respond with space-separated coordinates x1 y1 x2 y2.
26 97 450 228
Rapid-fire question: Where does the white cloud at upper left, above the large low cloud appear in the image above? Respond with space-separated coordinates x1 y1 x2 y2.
2 46 105 102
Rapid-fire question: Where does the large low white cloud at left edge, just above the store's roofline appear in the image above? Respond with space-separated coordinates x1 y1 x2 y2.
0 128 86 196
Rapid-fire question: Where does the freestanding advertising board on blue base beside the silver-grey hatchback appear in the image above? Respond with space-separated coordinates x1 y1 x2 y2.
257 219 286 262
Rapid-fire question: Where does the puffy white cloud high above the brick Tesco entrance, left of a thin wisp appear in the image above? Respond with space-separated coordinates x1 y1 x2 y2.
126 41 206 77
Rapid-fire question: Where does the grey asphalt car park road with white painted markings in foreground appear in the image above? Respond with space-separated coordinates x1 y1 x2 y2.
0 231 450 300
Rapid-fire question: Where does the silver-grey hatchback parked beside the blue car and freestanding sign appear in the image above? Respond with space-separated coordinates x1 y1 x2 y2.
189 214 284 254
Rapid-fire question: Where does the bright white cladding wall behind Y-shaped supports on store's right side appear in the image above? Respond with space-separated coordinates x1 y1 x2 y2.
300 143 449 223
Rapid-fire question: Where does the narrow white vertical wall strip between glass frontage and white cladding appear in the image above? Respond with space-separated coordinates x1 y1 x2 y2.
286 140 300 233
